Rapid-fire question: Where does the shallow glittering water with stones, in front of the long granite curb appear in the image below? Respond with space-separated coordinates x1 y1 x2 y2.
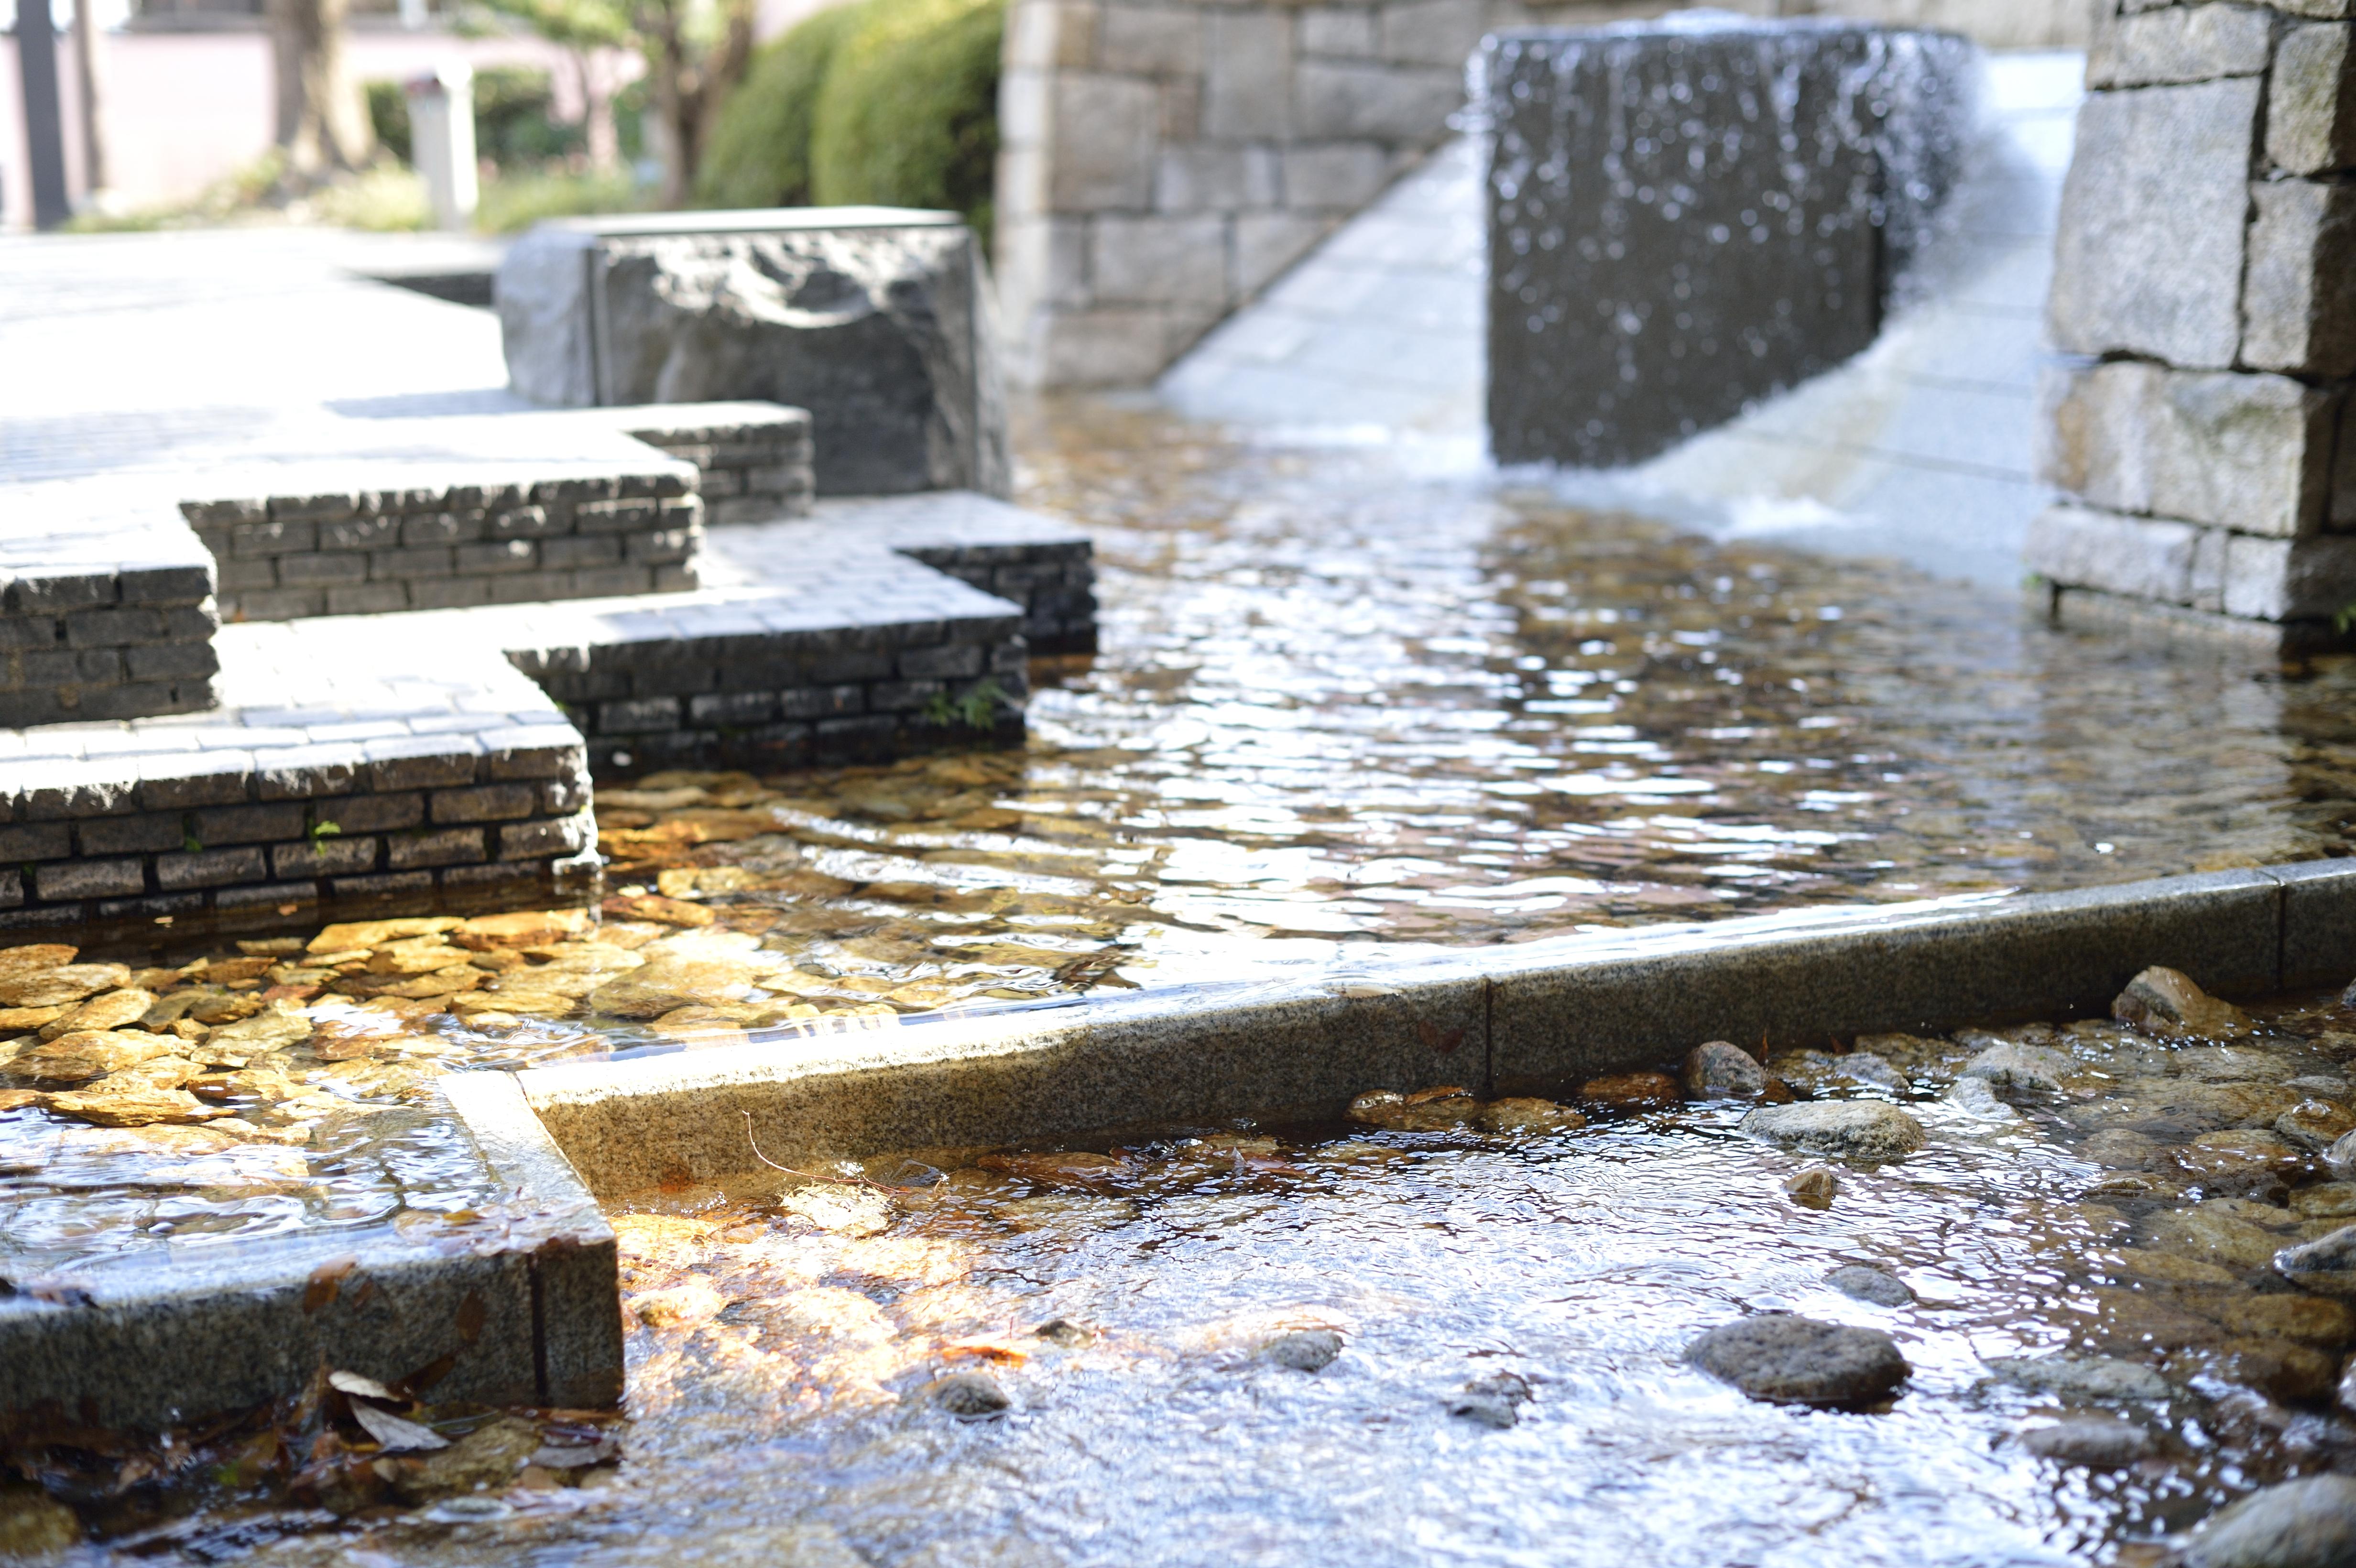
69 998 2356 1568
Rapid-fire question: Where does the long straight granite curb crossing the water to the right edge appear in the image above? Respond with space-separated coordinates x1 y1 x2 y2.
518 860 2356 1198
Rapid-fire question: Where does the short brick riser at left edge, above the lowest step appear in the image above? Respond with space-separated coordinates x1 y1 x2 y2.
0 565 219 730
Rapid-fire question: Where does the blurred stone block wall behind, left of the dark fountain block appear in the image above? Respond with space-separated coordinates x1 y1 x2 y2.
997 0 1663 386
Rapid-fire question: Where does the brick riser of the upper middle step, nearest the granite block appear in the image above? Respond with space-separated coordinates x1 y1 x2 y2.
181 471 702 621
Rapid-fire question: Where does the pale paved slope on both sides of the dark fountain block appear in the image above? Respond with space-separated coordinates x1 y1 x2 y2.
1162 52 2083 588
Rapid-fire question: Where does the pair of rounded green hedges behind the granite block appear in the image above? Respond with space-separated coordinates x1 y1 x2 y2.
698 0 1006 250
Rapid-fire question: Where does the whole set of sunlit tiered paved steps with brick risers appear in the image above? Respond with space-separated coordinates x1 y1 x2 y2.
0 231 1093 927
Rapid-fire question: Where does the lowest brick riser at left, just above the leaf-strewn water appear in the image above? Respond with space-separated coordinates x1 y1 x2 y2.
0 725 596 927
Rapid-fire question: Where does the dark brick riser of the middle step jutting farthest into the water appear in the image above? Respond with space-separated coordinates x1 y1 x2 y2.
509 605 1030 777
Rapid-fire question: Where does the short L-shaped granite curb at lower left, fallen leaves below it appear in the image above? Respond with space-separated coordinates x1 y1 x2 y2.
0 1071 622 1431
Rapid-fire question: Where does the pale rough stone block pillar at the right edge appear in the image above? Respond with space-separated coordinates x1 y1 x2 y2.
2026 0 2356 638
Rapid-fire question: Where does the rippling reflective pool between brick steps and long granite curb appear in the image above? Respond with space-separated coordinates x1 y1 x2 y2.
603 405 2356 1008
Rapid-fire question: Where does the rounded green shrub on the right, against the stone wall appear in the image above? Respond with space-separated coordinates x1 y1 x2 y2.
810 0 1006 250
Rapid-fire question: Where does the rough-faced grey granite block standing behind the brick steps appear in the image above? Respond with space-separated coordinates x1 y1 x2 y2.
497 207 1011 494
